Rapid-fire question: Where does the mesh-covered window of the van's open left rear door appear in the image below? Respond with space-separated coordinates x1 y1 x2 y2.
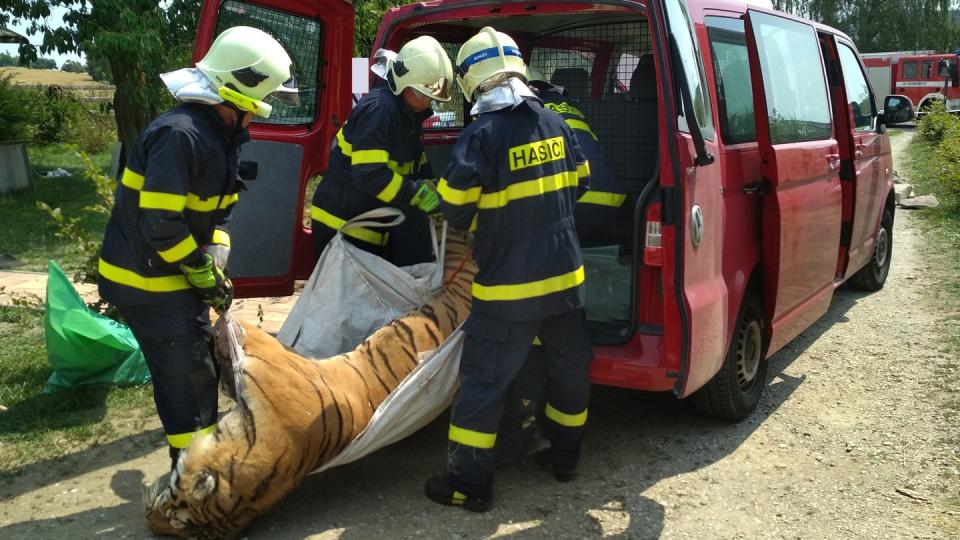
215 0 323 125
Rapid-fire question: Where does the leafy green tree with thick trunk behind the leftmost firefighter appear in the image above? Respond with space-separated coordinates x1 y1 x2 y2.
0 0 201 148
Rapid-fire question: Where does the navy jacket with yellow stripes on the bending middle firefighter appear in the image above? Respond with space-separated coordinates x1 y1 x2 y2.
310 86 433 246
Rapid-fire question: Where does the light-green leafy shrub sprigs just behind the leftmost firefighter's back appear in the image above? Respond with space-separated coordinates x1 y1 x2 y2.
37 148 117 283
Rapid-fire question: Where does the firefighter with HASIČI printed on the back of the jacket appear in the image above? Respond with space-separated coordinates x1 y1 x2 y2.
425 27 591 512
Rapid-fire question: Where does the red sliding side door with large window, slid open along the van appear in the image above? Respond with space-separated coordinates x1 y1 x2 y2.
745 9 842 354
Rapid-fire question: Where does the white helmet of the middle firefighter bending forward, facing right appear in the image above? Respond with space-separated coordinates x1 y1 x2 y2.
387 36 453 101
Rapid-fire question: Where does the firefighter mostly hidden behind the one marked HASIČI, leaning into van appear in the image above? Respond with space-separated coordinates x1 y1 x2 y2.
527 66 627 245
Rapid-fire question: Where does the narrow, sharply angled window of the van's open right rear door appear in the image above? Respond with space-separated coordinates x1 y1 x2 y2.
666 0 713 140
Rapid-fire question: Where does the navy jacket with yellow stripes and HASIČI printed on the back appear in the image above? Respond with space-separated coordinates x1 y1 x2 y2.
438 99 590 321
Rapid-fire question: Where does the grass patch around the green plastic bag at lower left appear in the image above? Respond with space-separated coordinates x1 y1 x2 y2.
0 306 156 478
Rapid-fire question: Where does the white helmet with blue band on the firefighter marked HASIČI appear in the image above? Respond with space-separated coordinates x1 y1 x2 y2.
457 26 527 101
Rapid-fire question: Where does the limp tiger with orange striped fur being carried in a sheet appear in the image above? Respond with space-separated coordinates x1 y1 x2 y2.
145 230 476 538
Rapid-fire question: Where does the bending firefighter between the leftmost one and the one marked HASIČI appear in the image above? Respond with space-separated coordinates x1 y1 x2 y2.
310 36 453 266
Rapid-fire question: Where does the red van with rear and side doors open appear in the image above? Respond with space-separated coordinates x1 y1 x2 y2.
195 0 913 419
